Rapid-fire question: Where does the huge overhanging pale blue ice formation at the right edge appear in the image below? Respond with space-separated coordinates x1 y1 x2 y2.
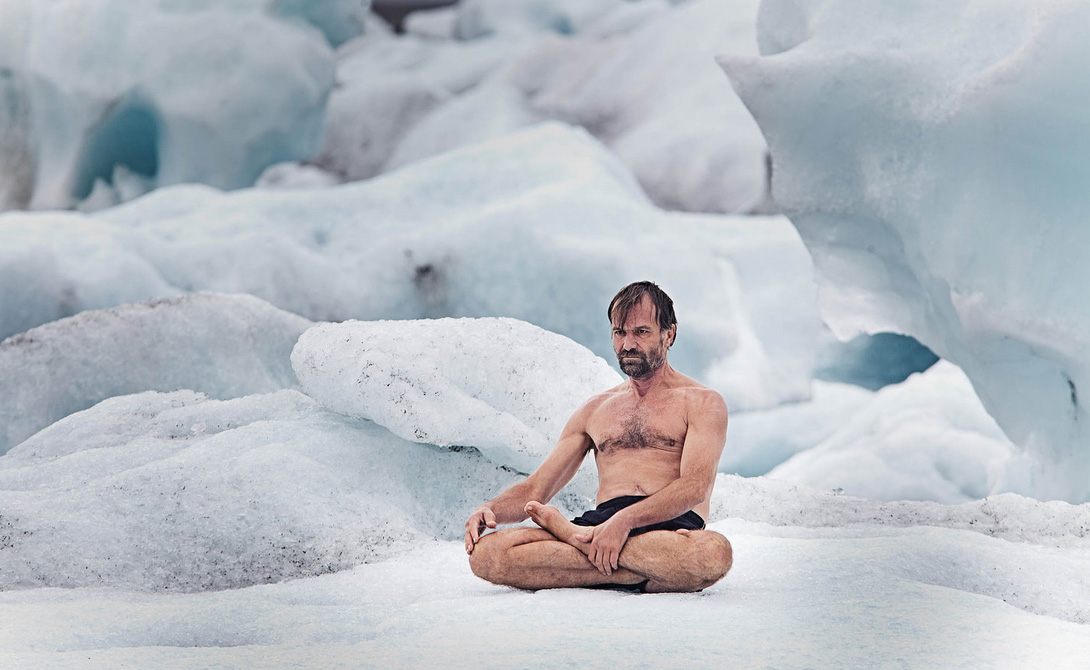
723 0 1090 501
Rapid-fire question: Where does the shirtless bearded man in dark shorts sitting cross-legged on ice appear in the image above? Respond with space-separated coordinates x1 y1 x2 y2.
465 281 732 593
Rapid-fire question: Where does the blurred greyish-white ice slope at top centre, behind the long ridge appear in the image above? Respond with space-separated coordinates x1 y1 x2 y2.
374 0 766 212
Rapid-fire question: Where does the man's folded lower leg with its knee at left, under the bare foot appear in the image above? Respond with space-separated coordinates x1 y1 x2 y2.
470 527 646 589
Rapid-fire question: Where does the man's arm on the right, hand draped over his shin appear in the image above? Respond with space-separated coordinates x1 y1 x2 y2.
576 390 727 575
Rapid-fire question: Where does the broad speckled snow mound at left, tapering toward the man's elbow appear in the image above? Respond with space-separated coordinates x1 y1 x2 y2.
0 390 513 592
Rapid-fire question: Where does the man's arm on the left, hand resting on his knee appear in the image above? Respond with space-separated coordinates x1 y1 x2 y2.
465 399 596 553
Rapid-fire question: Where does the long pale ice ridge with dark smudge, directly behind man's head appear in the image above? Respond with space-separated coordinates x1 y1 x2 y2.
0 123 820 411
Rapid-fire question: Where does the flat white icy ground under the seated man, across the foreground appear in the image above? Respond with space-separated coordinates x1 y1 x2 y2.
0 474 1090 670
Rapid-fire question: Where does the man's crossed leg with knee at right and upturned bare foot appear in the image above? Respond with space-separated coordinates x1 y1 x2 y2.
526 502 734 593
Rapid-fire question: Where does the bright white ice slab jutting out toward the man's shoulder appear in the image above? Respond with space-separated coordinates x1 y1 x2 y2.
291 318 621 473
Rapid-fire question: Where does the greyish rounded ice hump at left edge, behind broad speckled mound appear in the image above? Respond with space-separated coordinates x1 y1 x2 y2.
0 293 311 453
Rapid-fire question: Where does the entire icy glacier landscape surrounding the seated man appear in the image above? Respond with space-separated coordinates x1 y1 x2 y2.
0 0 1090 670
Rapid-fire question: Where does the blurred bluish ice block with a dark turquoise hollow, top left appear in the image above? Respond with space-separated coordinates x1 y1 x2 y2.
0 0 335 209
